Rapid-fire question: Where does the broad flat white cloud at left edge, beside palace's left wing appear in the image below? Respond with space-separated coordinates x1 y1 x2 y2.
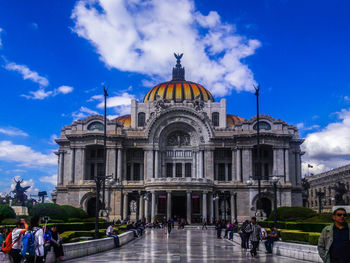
0 141 57 167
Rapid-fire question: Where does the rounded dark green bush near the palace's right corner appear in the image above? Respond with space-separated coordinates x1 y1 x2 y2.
269 206 317 221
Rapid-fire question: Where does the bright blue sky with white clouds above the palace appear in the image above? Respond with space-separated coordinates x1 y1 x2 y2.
0 0 350 198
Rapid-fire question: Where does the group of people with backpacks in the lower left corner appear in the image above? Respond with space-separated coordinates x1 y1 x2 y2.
0 216 64 263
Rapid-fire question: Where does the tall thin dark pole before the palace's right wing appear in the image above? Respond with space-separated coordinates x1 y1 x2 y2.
254 85 262 217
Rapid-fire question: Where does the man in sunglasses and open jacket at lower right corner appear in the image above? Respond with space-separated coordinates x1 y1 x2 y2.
317 208 350 263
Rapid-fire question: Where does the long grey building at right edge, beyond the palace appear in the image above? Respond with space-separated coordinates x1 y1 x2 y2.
306 164 350 212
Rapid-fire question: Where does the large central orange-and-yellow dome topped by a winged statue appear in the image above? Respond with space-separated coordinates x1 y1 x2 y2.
143 54 215 102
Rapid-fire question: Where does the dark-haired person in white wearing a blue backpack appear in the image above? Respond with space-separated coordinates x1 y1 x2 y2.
29 216 45 263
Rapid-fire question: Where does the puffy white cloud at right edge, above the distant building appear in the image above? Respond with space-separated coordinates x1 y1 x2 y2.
302 109 350 174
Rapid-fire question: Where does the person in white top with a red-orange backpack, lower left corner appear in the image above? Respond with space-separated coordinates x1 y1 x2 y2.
10 218 28 263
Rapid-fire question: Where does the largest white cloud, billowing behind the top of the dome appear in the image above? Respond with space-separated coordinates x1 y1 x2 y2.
71 0 261 96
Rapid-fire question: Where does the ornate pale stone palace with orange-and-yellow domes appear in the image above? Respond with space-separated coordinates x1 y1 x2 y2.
53 57 303 223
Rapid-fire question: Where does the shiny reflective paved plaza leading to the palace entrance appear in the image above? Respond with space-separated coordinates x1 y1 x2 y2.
66 229 304 263
